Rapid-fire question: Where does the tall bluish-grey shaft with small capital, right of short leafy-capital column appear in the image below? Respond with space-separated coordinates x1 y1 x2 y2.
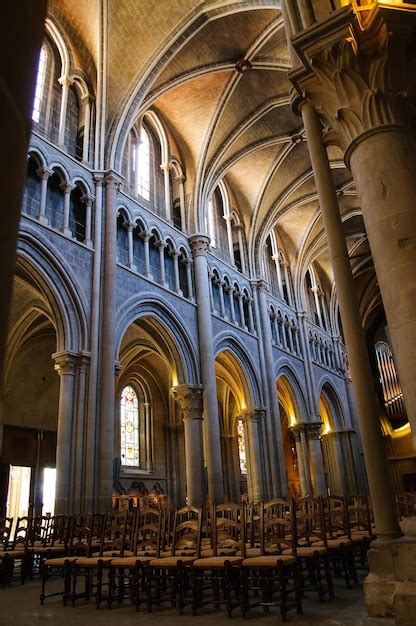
189 234 224 503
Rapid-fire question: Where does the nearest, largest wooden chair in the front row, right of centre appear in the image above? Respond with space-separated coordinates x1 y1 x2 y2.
241 499 302 621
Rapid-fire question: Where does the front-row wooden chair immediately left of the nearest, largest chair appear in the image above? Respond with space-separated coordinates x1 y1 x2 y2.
192 503 246 617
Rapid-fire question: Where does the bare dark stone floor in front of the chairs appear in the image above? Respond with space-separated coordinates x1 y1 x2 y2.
0 580 394 626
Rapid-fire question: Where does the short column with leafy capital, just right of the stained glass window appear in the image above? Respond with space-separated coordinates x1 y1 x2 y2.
172 384 205 506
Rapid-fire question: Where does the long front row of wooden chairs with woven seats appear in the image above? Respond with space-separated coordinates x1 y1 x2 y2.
40 496 372 618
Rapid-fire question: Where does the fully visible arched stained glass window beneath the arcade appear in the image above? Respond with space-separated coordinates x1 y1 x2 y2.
120 385 140 467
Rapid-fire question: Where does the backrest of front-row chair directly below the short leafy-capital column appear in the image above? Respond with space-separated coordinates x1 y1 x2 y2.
172 506 203 557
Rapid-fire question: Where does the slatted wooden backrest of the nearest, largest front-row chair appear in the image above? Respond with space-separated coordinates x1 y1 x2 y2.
260 498 296 556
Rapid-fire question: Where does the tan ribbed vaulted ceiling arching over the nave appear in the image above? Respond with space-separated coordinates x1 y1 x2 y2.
49 0 378 326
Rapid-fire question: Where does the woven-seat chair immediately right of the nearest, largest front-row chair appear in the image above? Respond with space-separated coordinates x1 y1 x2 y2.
283 497 334 602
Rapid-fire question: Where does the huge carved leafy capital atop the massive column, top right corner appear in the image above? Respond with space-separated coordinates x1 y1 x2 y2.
289 3 416 154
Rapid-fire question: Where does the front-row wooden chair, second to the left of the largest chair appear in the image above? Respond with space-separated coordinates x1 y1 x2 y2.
147 506 203 614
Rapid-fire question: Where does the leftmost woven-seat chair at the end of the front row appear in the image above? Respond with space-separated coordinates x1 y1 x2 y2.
40 513 94 606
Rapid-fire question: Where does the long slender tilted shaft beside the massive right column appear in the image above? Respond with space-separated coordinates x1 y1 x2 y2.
301 102 399 537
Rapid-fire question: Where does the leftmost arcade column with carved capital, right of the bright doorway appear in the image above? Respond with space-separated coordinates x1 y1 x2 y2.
52 352 76 515
